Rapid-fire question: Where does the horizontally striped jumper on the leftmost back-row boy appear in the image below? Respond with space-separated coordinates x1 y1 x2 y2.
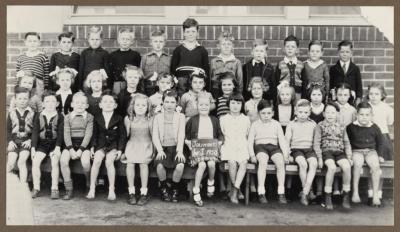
16 53 50 89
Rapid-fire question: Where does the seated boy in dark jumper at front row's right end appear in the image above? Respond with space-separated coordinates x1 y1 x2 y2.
346 102 384 206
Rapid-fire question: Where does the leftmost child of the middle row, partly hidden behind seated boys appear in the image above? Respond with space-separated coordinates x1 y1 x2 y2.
9 70 43 112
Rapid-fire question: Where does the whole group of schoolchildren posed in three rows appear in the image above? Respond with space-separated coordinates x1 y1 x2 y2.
7 18 394 210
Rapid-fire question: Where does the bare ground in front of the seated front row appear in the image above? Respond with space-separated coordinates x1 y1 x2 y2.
33 190 394 225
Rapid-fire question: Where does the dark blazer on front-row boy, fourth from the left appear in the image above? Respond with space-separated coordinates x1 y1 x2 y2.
92 112 126 151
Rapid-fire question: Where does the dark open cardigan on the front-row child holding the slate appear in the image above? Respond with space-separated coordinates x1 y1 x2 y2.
185 115 224 141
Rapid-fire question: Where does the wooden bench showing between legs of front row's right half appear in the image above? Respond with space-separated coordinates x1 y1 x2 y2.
220 161 394 205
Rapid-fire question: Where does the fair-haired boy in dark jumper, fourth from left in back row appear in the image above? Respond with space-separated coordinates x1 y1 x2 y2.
107 28 141 94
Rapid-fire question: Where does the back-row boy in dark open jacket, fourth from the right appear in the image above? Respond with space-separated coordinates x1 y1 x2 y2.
243 39 276 102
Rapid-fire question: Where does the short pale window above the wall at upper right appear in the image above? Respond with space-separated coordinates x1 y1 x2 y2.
310 6 361 17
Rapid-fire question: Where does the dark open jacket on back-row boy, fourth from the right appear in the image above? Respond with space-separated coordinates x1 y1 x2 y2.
243 59 276 102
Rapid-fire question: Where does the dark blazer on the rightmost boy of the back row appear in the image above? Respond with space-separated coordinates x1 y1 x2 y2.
329 60 363 102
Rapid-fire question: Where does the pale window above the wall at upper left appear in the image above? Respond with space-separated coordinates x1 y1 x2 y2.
74 6 165 16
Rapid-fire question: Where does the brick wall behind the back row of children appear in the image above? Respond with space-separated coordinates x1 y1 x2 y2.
7 25 394 103
